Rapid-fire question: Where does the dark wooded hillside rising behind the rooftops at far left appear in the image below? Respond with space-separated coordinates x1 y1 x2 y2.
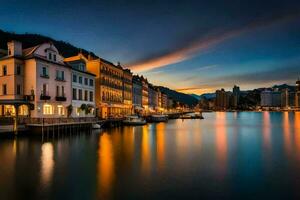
0 29 96 57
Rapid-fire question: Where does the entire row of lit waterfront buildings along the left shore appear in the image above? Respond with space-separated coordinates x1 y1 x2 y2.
0 41 172 118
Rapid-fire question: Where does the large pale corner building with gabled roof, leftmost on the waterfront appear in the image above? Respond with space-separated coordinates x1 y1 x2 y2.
0 41 71 118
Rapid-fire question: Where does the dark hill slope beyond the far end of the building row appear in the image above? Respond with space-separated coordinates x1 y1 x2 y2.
159 86 198 106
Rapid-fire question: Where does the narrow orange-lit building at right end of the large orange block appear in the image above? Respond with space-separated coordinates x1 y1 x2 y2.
123 69 133 115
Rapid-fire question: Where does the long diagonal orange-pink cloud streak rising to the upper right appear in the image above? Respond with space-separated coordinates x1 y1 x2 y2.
129 11 300 72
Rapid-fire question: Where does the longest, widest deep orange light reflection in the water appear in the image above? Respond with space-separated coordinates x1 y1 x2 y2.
98 134 115 199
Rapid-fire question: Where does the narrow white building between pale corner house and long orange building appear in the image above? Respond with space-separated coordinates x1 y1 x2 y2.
64 53 95 117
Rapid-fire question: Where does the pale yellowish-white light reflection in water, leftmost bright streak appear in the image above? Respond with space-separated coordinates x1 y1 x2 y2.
41 142 54 186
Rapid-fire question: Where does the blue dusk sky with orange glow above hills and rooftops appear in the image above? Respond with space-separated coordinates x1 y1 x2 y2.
0 0 300 94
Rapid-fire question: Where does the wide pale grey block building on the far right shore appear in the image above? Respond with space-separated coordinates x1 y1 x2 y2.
260 90 281 107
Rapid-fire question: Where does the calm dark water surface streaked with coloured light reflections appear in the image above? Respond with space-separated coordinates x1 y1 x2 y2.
0 112 300 199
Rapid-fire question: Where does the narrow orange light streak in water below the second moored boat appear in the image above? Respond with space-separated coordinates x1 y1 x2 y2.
156 123 165 169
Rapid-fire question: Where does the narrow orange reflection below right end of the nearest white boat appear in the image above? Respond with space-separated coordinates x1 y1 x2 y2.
141 126 151 172
